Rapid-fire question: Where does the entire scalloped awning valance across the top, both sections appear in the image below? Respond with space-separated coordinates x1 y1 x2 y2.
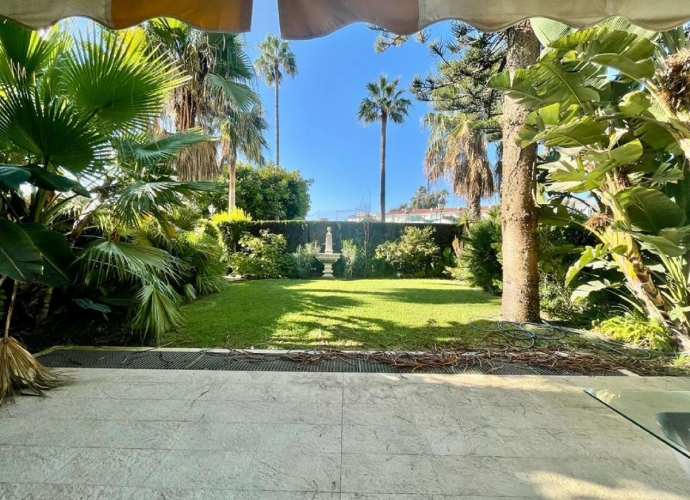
0 0 690 39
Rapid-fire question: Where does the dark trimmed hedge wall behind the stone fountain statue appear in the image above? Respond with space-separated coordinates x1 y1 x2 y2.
218 221 462 252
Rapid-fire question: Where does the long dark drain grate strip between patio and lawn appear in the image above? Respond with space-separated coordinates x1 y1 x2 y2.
39 349 625 376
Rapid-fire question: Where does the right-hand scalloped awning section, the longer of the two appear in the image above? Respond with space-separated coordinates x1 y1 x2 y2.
278 0 690 39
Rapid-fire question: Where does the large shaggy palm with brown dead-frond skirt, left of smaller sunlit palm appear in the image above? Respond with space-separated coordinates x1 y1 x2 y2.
146 18 260 184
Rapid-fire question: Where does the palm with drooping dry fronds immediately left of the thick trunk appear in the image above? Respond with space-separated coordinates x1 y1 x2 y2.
423 113 495 220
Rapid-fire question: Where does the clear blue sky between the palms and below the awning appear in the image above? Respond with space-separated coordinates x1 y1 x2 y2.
246 1 484 219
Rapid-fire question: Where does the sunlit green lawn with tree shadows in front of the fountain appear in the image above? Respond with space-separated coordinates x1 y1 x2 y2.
163 280 500 349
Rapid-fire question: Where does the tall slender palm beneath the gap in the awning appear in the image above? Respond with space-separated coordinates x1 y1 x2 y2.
254 34 297 165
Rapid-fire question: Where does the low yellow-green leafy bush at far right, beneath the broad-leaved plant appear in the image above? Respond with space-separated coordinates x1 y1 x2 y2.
594 313 674 352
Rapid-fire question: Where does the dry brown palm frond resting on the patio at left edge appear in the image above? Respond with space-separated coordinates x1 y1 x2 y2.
0 337 69 405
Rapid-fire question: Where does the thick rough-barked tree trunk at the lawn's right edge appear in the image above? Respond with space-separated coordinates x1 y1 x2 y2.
501 21 539 321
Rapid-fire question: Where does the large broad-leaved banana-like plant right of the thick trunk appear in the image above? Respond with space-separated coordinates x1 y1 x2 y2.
493 22 690 342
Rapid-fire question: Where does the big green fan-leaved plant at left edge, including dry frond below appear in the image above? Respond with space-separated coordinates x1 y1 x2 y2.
0 21 194 400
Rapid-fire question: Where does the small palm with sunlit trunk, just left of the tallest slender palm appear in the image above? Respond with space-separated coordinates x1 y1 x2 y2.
220 106 268 213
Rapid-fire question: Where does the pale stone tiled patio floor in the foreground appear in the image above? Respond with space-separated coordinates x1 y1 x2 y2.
0 369 690 500
